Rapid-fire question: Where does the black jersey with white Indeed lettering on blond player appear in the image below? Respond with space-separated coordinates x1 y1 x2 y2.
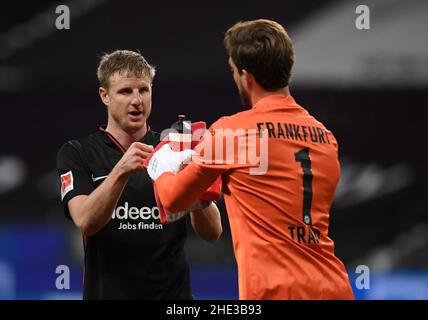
57 128 192 299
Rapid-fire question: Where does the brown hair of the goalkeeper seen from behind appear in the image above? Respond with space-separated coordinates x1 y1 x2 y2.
224 19 295 91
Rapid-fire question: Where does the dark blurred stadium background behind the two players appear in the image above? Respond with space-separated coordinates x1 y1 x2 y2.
0 0 428 299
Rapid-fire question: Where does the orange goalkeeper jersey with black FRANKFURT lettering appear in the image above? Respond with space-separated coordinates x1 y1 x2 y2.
156 95 353 299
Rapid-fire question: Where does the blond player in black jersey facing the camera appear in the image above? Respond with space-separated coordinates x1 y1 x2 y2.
57 50 222 299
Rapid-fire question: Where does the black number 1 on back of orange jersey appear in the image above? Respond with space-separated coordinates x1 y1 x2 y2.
294 148 313 226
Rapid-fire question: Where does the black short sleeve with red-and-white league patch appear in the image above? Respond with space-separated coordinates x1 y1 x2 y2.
56 141 94 218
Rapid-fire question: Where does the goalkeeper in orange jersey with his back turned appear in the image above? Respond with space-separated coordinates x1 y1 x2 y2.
148 19 354 299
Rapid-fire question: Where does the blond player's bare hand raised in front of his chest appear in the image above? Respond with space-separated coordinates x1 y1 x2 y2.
116 142 153 175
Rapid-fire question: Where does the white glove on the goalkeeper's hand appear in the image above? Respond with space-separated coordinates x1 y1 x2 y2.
147 143 194 181
